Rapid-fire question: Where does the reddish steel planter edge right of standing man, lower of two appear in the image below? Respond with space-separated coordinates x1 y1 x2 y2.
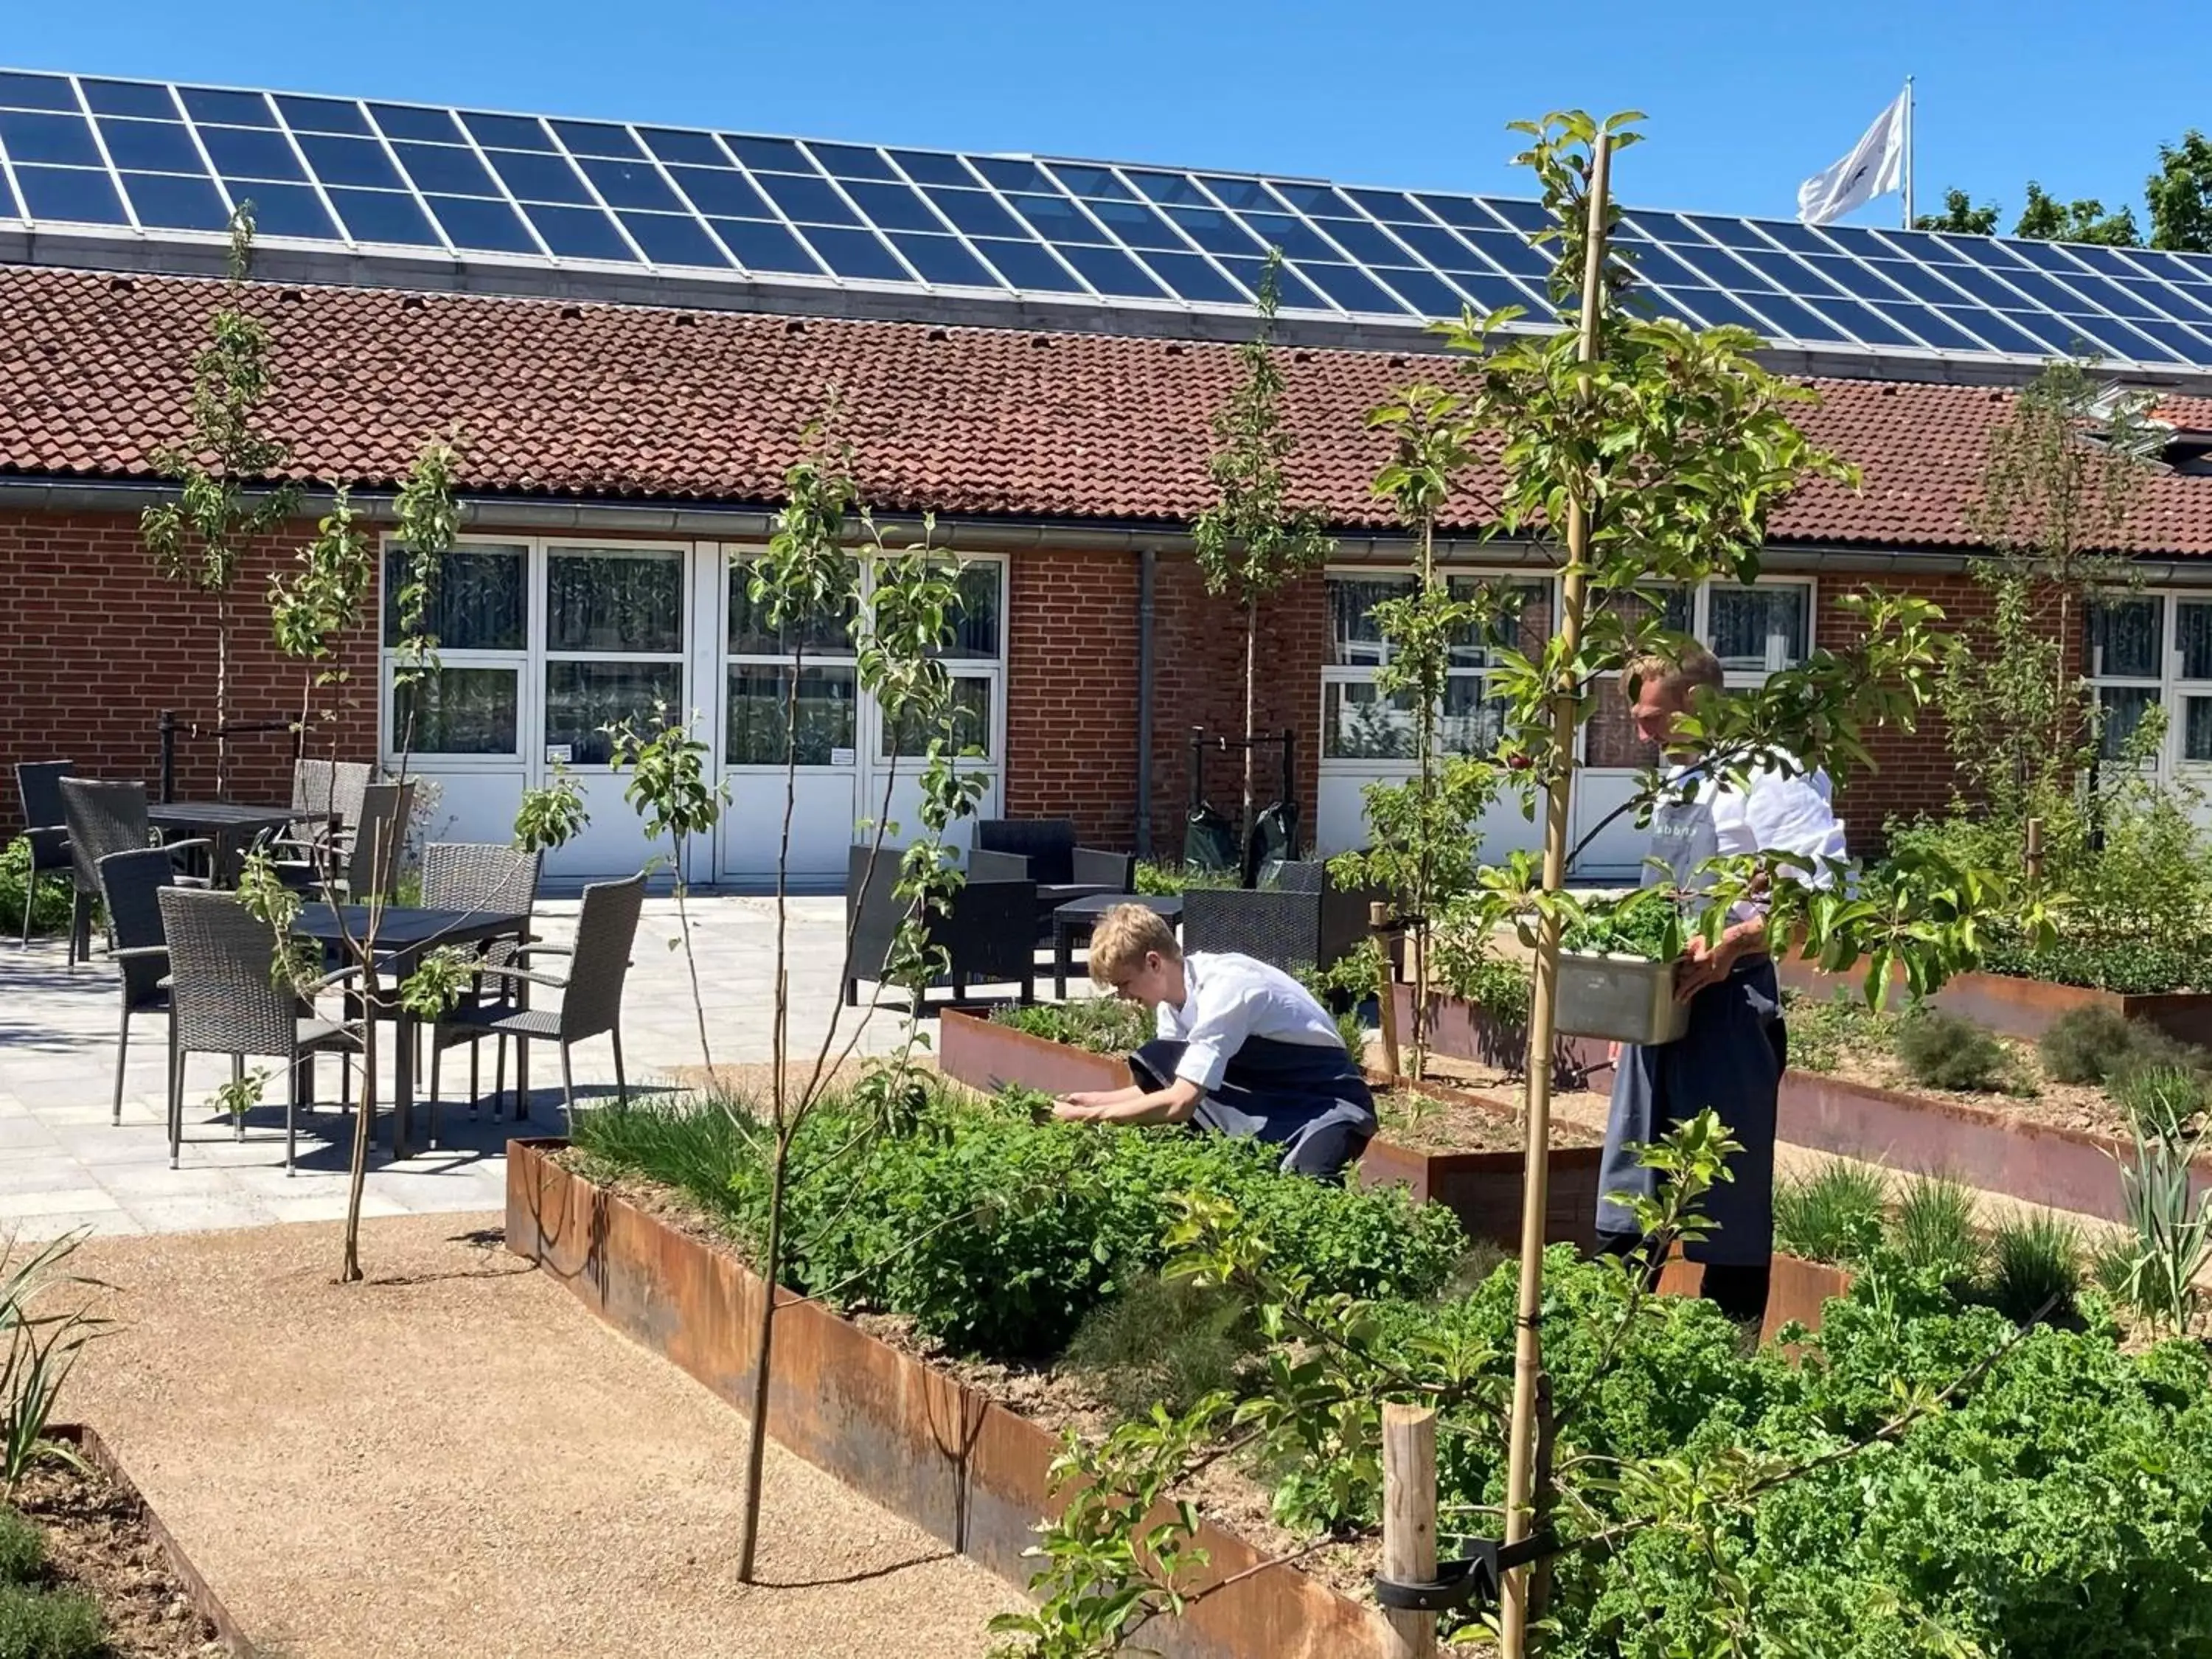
1776 1071 2212 1221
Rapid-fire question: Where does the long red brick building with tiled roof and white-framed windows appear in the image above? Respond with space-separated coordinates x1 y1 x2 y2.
13 75 2212 883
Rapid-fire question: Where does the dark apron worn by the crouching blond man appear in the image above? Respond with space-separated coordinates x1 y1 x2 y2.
1128 1037 1376 1181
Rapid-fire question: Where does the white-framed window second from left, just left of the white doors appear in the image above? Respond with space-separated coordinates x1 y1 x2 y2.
544 544 686 765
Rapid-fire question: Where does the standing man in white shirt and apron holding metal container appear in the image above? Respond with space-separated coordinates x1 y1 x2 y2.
1597 648 1843 1321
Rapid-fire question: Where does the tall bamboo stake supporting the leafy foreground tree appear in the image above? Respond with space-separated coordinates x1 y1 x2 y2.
1500 133 1613 1659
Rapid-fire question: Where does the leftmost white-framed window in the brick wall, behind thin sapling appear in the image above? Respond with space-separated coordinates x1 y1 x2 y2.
385 542 531 757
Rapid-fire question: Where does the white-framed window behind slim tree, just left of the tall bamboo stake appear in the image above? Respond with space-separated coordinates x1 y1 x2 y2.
1321 573 1551 761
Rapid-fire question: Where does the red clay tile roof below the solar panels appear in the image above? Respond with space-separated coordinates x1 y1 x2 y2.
0 268 2212 553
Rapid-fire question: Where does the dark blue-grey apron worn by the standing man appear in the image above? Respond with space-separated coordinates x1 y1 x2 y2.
1597 801 1787 1267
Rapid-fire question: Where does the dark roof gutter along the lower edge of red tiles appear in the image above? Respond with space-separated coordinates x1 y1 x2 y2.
13 478 2212 586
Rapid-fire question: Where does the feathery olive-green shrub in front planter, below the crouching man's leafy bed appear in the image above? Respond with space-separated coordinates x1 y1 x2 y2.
1066 1279 1259 1418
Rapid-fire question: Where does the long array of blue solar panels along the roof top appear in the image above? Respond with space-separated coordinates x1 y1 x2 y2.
0 71 2212 367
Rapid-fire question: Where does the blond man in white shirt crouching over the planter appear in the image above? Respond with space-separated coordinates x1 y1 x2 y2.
1053 905 1376 1181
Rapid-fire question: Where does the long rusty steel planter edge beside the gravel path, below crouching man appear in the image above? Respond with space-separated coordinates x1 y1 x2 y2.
507 1141 1387 1659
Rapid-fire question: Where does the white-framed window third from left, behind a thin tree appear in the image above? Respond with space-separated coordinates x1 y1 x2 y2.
721 560 860 765
